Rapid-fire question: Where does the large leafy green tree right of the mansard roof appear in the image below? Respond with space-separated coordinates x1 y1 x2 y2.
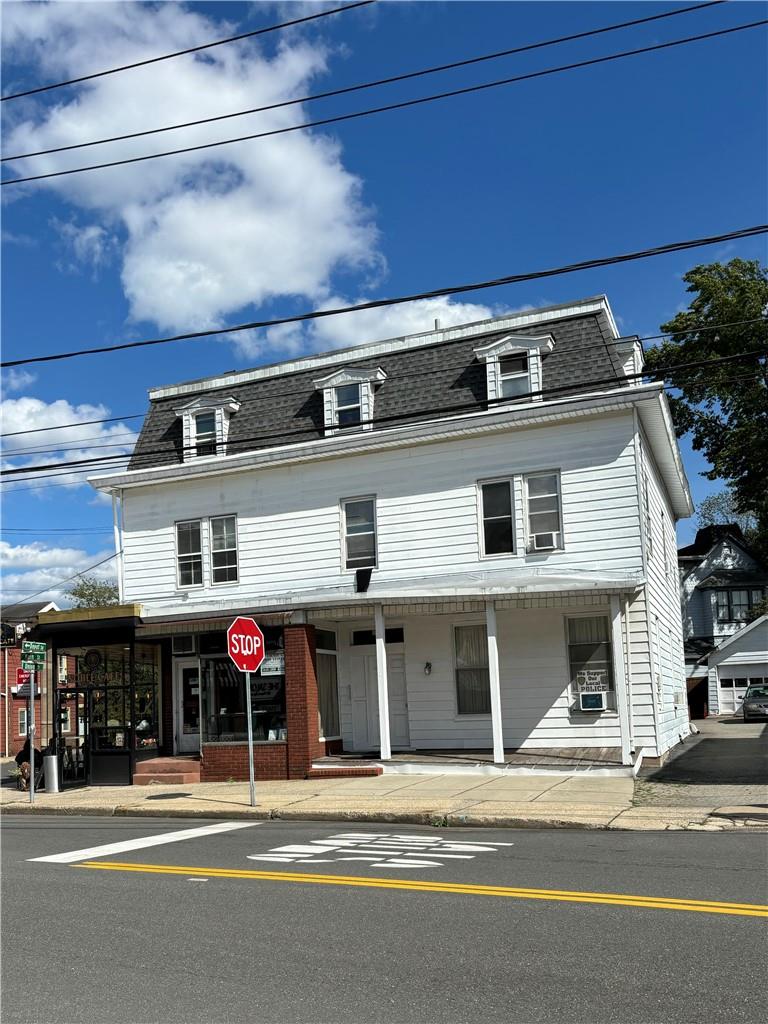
646 259 768 554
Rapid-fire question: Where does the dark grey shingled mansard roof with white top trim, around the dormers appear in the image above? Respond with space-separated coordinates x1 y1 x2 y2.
129 296 635 469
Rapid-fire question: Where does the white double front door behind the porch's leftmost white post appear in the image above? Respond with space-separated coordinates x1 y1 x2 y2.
349 651 411 751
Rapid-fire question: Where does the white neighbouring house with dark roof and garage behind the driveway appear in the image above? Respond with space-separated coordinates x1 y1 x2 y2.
678 523 768 718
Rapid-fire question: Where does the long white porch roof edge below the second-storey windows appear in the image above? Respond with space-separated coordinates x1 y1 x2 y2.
135 567 645 632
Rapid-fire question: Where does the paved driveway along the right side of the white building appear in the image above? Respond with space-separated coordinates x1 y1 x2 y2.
635 716 768 807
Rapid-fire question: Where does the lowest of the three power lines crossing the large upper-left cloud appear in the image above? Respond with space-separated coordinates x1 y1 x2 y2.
0 18 768 185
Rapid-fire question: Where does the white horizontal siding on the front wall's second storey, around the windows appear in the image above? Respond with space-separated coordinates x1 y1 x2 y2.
124 415 643 611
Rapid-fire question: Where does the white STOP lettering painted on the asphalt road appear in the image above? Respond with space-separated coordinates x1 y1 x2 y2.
248 833 514 867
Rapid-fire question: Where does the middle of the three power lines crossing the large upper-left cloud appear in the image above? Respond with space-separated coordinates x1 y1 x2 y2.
0 0 725 163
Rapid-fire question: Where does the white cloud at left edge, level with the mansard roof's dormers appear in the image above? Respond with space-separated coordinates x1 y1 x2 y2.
0 395 137 496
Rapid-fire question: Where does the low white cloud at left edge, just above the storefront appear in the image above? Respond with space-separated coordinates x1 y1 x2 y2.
0 542 115 607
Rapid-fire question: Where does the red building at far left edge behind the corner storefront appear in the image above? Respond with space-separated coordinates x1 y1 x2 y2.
0 601 58 757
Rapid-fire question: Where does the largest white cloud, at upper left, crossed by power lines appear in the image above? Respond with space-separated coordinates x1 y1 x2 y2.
4 3 383 330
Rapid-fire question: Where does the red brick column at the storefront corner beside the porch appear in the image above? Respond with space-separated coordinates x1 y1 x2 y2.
284 625 325 778
